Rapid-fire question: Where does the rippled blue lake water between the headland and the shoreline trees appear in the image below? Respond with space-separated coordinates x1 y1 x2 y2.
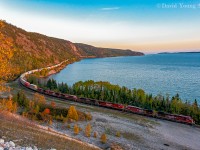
50 53 200 102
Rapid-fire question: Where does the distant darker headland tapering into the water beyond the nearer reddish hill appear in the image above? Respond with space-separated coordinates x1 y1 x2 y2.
75 43 144 57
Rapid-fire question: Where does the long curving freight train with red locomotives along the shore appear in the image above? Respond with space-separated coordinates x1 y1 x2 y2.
19 62 195 125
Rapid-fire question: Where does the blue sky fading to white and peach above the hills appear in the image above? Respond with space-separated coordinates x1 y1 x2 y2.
0 0 200 53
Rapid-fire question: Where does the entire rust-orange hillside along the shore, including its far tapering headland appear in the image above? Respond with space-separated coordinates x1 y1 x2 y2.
0 20 143 78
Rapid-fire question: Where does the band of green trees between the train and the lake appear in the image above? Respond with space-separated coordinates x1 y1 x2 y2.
44 79 200 124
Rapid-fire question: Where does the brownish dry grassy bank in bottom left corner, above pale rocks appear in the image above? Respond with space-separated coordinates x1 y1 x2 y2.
0 113 98 150
